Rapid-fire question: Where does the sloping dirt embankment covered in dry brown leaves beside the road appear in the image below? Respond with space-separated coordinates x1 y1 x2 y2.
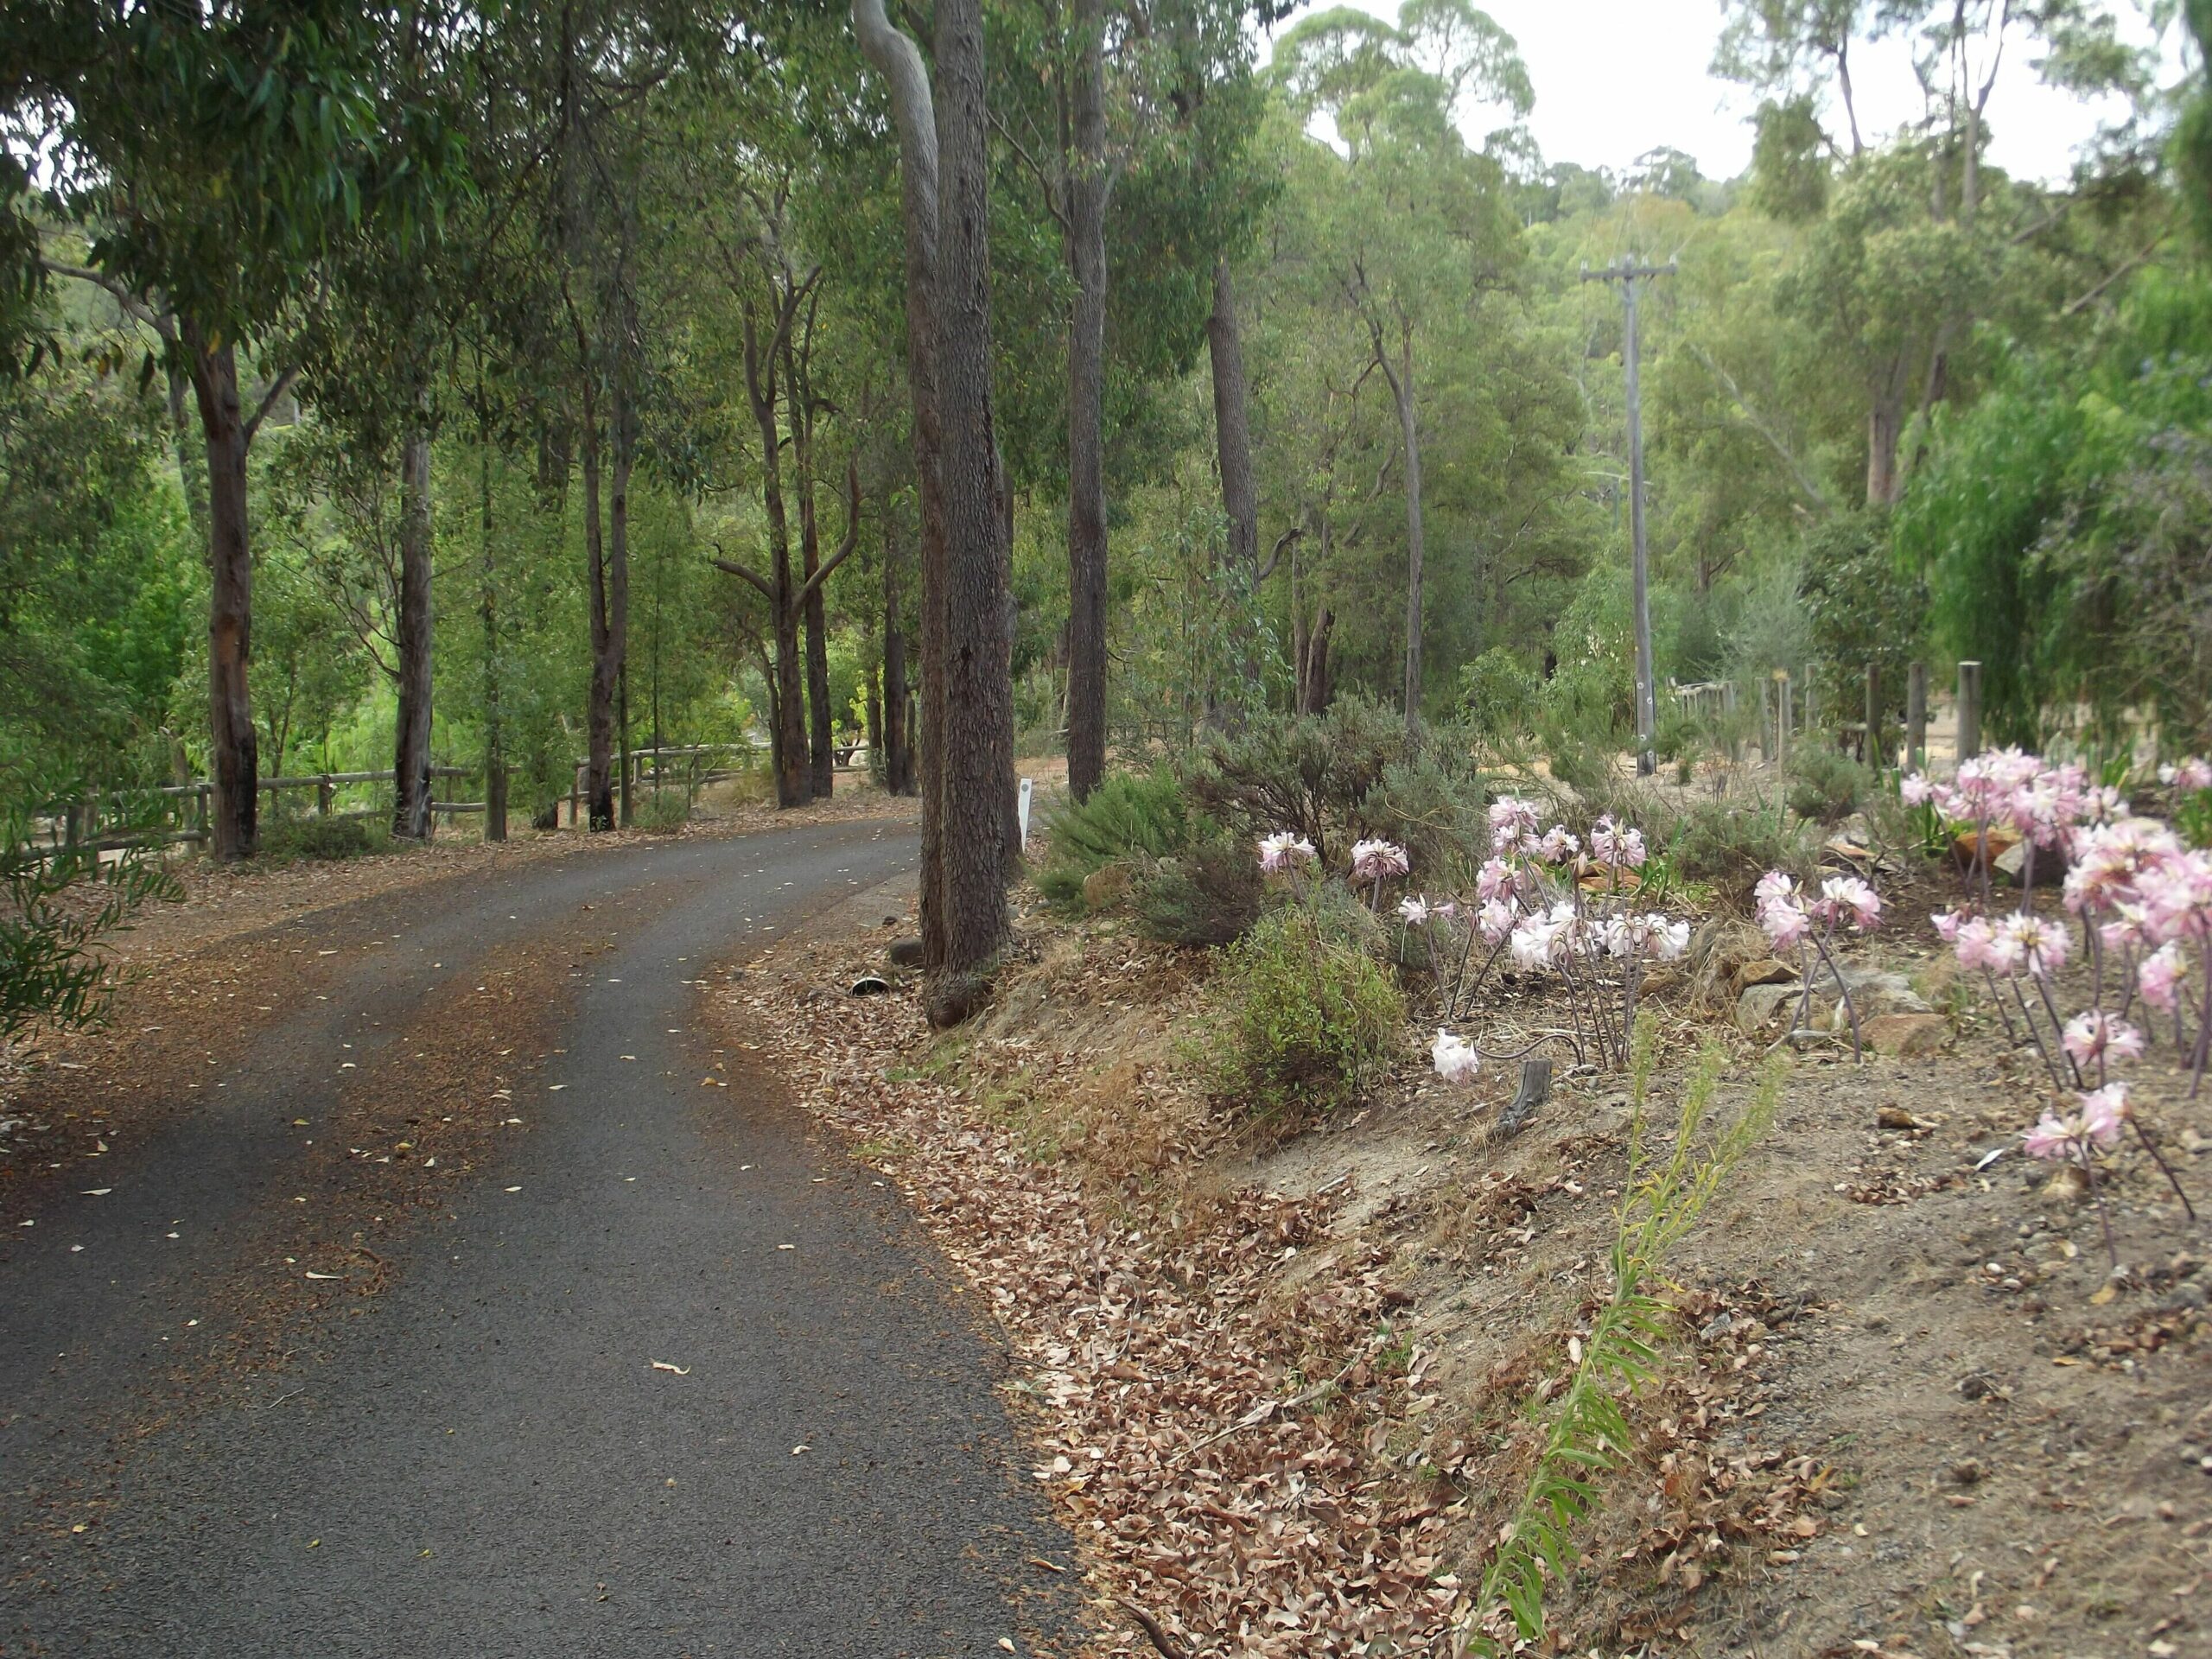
721 885 2212 1659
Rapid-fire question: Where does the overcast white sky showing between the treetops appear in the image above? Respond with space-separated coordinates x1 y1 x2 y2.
1281 0 2185 181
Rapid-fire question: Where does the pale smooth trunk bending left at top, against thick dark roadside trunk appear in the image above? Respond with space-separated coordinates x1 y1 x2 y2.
852 0 947 969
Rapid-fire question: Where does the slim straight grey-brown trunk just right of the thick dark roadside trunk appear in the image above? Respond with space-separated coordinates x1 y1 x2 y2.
1066 0 1109 801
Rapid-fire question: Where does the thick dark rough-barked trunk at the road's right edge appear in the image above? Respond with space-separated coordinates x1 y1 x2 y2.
931 0 1013 1000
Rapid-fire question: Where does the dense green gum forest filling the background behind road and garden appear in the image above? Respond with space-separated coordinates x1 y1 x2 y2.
0 0 2212 871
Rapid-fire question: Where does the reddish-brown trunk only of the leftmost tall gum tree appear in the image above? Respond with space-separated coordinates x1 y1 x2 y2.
183 321 259 862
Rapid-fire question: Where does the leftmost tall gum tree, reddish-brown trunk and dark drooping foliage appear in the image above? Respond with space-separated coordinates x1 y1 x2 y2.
9 0 458 861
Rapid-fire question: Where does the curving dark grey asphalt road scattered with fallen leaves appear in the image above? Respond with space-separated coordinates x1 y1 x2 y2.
0 823 1068 1659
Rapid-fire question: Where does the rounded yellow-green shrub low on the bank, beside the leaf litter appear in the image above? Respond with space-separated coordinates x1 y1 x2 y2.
1214 907 1405 1115
